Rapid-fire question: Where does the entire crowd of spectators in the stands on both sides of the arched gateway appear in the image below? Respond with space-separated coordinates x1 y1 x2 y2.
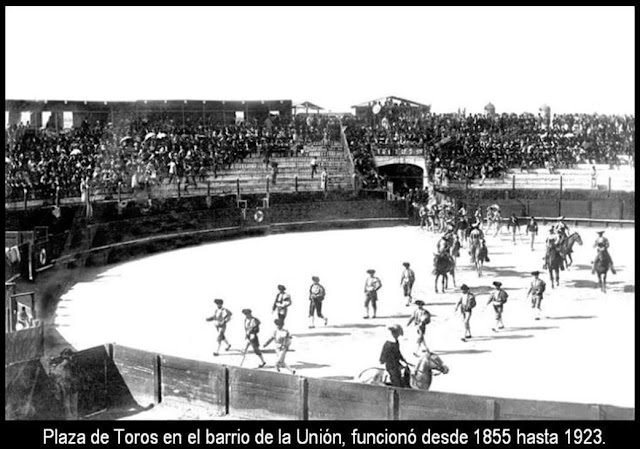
5 104 635 200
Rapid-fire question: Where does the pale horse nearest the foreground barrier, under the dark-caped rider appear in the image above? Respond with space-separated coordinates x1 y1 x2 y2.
357 351 449 391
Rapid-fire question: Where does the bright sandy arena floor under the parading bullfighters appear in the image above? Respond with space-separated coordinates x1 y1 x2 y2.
55 227 635 407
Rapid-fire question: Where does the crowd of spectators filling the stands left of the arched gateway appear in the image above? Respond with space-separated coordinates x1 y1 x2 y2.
5 115 340 200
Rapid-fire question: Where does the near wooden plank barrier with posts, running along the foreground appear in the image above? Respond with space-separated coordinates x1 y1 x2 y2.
5 336 635 421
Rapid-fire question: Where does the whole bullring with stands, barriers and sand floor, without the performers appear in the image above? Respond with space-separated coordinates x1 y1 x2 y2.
5 97 635 420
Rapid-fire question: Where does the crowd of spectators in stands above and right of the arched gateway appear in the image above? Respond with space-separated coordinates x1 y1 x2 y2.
345 105 635 185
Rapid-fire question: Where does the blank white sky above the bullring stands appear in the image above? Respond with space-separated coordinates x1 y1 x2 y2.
5 6 635 114
